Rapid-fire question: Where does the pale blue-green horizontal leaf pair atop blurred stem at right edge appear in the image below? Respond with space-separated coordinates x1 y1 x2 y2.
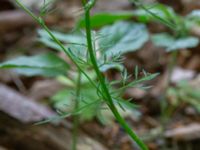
152 33 199 52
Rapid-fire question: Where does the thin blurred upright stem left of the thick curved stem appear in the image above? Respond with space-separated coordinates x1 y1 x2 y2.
72 71 81 150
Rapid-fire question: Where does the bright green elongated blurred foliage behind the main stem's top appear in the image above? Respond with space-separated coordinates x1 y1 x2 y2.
77 3 180 28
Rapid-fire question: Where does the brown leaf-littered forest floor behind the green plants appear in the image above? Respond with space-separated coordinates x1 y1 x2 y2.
0 0 200 150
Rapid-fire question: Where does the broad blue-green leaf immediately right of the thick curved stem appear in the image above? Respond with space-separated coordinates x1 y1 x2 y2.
99 22 149 57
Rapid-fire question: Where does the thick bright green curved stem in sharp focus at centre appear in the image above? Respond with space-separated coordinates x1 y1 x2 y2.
83 0 148 150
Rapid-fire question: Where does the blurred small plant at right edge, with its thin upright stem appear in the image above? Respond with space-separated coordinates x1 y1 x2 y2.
149 6 199 120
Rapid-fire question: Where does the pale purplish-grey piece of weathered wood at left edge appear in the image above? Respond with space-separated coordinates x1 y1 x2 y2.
0 84 55 123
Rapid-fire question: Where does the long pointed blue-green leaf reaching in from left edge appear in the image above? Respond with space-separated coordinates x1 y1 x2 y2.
0 53 69 76
